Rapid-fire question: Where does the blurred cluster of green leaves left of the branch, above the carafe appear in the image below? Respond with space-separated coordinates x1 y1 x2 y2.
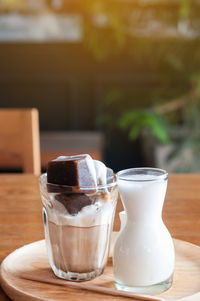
98 89 172 143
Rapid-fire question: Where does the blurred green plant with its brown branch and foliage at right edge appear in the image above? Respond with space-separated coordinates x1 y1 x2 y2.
98 73 200 172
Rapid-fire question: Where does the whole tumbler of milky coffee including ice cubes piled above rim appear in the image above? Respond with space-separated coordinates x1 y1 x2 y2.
40 155 118 281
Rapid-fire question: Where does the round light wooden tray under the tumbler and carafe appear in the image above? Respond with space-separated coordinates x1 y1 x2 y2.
1 239 200 301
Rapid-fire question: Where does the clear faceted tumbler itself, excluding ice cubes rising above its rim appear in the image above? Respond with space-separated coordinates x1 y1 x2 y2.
40 174 118 281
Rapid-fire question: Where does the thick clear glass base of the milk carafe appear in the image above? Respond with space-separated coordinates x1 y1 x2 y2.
115 276 173 295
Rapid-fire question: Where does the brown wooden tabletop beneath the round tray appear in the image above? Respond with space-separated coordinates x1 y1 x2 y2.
0 174 200 301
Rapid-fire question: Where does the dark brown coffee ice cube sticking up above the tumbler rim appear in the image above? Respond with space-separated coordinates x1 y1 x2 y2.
47 155 97 187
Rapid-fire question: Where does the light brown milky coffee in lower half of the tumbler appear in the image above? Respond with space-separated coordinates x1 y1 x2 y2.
48 221 111 273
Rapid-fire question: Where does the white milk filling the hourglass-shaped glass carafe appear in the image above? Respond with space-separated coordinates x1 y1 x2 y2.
113 174 174 287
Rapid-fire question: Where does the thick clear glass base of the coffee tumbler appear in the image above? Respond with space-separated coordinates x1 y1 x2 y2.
52 266 104 281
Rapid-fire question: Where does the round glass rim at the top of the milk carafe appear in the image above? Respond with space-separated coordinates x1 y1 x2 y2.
116 167 168 182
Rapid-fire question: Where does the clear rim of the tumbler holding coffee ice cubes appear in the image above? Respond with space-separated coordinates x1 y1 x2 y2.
39 172 117 192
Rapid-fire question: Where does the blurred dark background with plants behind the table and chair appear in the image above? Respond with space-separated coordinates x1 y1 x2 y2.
0 0 200 172
